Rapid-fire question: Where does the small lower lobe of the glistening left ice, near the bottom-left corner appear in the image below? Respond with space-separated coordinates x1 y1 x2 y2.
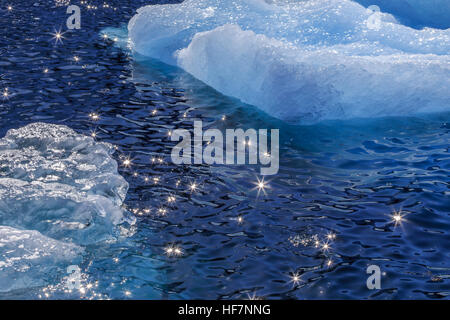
0 226 83 292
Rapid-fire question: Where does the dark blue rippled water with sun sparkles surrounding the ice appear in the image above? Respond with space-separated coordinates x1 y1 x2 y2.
0 0 450 299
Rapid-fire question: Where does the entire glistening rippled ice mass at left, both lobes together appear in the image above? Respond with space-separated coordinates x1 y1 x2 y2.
0 123 132 292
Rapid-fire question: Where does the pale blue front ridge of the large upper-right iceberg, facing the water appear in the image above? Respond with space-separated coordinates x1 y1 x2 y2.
178 25 450 123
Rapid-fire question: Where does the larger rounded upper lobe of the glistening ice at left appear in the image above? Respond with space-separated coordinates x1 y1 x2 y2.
0 123 128 245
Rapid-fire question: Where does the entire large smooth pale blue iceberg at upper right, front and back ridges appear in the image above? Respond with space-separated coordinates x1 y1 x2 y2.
128 0 450 123
